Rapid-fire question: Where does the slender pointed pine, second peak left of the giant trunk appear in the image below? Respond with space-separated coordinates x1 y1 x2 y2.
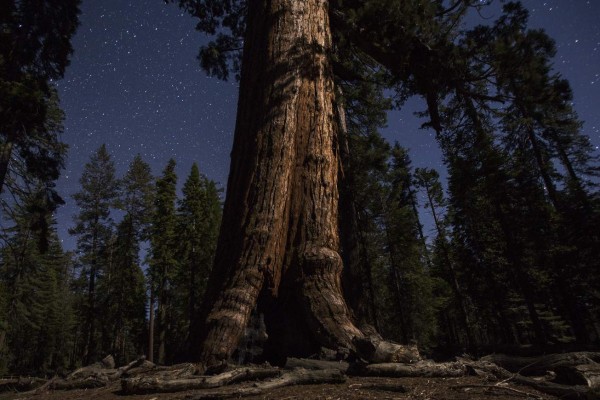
149 159 178 364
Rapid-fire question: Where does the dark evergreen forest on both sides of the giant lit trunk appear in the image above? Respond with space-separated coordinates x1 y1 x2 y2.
0 0 600 392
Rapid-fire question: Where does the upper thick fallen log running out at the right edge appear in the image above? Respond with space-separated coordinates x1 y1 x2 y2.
481 351 600 375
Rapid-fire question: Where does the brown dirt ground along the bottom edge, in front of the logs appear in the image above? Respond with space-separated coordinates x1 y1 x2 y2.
0 376 557 400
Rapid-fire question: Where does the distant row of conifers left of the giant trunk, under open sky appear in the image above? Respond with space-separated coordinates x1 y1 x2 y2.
0 146 221 374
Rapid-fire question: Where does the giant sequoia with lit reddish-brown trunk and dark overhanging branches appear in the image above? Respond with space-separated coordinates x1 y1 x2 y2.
164 0 482 365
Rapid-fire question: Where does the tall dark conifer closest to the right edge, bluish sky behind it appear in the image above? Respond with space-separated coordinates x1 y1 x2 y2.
452 3 598 343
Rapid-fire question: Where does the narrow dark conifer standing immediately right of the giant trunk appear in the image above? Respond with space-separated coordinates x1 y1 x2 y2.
334 57 391 330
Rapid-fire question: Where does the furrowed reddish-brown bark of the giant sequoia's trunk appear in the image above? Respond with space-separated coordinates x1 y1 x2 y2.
199 0 361 365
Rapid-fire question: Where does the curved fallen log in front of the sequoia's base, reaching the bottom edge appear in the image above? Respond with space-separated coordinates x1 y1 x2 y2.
188 369 346 400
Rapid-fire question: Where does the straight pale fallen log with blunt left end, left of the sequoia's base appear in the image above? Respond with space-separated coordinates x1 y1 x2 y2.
121 367 281 394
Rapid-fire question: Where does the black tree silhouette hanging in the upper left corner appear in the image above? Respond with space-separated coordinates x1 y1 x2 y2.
0 0 80 211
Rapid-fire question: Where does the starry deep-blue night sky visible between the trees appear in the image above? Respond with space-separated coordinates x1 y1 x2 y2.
57 0 600 250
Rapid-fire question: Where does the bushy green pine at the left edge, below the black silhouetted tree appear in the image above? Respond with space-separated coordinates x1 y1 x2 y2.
0 184 75 374
